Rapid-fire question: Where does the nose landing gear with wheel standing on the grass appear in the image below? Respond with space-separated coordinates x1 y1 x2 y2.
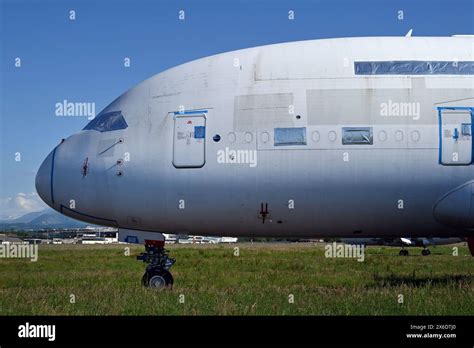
137 240 176 290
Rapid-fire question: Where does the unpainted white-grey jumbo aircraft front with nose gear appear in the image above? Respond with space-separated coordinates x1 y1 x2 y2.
36 36 474 288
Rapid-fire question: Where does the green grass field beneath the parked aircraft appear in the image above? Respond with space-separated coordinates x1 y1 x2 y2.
0 243 474 315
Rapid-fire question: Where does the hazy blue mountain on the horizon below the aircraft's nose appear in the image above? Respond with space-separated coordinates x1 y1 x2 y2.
0 209 91 230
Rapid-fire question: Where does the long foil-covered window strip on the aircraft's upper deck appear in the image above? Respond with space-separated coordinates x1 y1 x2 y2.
354 60 474 75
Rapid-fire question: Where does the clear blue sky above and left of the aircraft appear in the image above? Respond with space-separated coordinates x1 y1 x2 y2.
0 0 474 218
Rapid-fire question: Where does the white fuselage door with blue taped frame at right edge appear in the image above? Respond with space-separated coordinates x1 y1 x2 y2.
438 107 472 165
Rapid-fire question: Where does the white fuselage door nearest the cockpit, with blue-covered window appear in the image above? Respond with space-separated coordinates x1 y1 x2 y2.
173 115 206 168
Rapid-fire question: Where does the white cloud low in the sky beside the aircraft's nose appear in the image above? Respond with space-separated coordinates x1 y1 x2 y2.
0 192 47 218
